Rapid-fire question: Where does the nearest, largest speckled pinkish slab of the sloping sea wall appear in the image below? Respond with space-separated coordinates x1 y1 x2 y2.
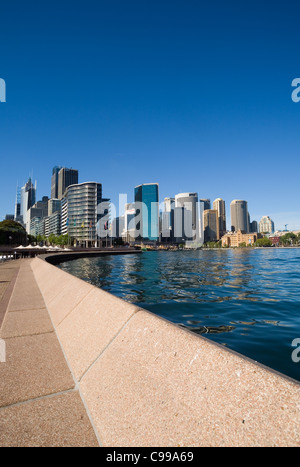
81 311 300 446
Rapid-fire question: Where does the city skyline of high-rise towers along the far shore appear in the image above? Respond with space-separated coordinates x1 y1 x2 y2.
7 166 284 243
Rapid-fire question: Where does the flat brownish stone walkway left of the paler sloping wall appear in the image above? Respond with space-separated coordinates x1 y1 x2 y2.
0 259 99 447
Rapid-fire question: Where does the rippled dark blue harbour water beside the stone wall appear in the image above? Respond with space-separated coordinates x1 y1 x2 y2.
60 248 300 381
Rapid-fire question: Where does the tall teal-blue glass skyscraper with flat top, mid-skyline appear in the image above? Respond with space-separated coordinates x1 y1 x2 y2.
134 183 159 241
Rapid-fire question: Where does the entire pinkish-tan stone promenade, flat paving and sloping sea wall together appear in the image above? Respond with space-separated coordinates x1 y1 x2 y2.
0 254 300 447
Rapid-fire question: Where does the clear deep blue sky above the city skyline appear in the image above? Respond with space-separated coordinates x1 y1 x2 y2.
0 0 300 229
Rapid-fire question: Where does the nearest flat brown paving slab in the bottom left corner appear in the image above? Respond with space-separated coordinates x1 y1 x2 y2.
0 391 98 447
